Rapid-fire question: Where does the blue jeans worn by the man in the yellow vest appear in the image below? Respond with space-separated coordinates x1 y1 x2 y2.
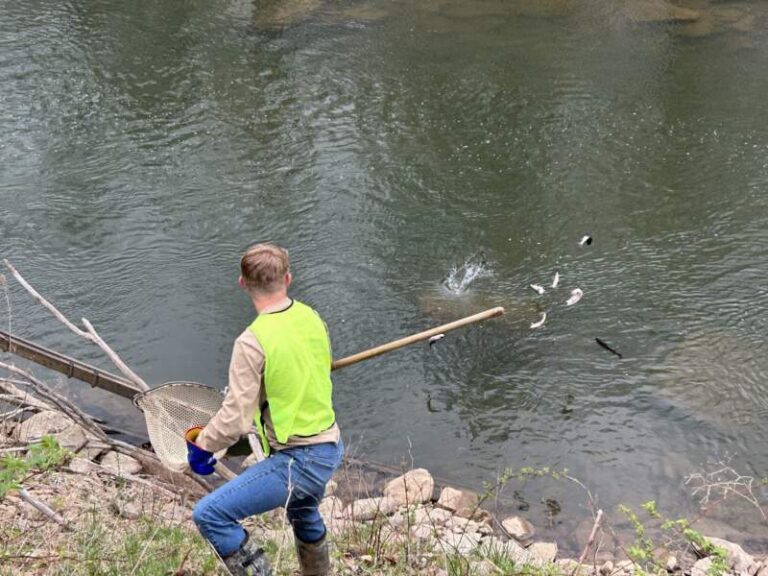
192 440 344 557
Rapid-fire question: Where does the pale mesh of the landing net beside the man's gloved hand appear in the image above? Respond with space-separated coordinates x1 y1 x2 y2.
133 382 224 471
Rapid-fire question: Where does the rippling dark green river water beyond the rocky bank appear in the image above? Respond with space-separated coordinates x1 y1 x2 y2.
0 0 768 547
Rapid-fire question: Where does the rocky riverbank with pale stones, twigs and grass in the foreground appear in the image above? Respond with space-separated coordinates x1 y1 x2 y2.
0 406 768 576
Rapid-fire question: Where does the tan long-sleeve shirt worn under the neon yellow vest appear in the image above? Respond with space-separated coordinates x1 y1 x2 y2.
196 299 340 452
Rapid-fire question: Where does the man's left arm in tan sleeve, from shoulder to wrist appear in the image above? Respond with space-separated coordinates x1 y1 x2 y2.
196 330 264 452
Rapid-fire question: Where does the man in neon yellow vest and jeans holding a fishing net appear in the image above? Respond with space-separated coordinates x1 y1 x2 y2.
186 244 344 576
